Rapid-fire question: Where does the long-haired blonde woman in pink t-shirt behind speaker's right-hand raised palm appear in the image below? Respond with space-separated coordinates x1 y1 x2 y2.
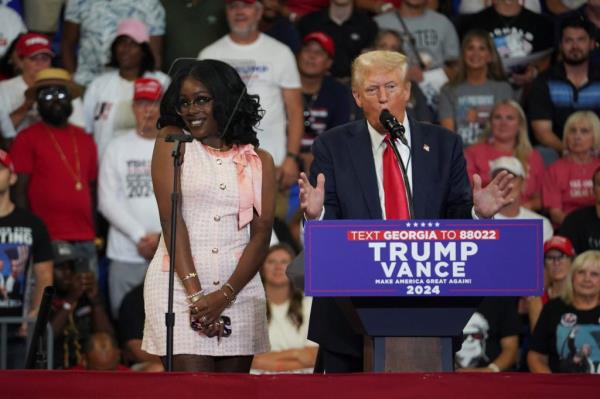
465 100 544 210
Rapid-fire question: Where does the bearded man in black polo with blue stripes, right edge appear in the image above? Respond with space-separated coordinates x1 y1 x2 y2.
527 17 600 153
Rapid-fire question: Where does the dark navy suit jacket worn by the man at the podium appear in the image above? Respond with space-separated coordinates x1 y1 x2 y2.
308 118 473 357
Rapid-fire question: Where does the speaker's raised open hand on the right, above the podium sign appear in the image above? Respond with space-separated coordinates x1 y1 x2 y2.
473 170 516 219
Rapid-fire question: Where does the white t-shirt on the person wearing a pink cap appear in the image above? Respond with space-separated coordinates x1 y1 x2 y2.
83 71 170 159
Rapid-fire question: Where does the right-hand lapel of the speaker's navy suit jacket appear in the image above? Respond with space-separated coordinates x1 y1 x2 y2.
408 118 429 219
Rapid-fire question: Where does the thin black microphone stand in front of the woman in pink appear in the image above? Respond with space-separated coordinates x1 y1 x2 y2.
165 134 194 372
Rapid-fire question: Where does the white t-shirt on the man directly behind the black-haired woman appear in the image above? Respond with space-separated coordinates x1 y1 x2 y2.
198 33 301 165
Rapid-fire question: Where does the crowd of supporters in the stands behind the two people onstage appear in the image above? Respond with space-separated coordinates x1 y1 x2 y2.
0 0 600 373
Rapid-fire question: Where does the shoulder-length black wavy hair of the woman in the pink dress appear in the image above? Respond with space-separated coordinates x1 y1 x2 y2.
158 60 264 147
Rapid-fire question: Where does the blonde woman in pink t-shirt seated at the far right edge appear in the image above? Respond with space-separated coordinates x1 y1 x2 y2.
542 111 600 226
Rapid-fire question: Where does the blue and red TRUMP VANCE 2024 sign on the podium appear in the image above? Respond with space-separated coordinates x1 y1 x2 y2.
305 219 544 297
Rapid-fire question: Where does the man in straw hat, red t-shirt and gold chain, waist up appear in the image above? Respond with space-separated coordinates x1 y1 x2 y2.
11 68 97 272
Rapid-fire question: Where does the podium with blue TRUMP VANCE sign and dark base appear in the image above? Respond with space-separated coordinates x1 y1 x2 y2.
304 220 543 372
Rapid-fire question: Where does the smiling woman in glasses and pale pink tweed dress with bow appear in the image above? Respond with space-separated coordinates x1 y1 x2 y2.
143 60 276 372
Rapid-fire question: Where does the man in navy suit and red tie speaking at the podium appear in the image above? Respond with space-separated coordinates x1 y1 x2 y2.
299 51 513 373
